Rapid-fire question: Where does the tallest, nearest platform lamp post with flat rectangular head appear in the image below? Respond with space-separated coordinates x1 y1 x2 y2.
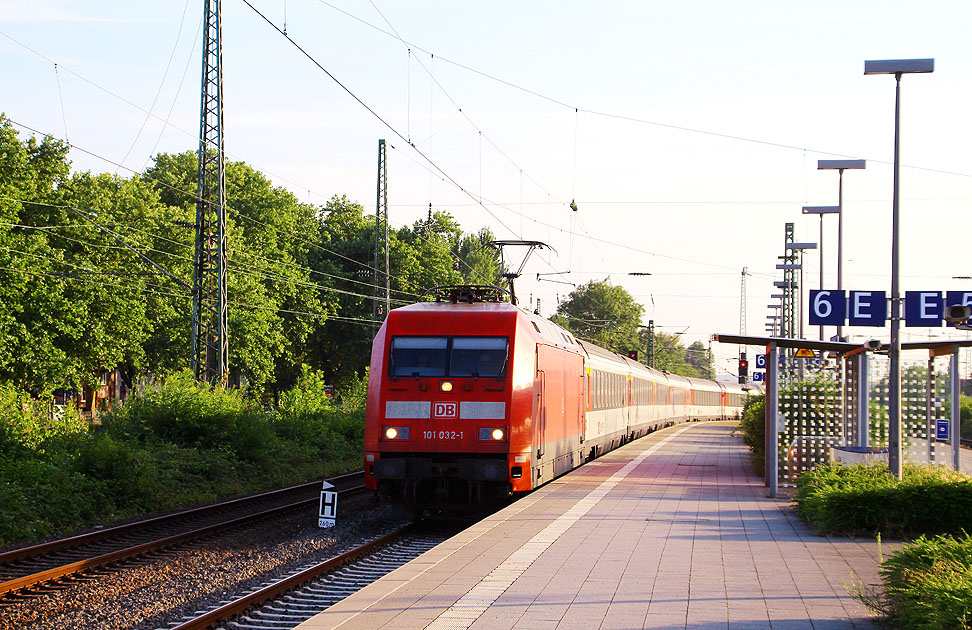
864 59 935 479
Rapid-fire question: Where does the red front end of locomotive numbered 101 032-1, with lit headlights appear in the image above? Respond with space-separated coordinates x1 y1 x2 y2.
365 286 529 513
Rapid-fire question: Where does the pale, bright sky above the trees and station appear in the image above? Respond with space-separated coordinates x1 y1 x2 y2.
0 0 972 375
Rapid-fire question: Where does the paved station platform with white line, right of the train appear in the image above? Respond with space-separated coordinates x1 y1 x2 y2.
299 422 889 630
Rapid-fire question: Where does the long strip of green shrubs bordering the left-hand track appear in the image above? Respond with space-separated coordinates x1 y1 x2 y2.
0 372 365 546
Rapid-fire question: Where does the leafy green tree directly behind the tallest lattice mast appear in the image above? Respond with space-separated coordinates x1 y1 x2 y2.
146 152 327 391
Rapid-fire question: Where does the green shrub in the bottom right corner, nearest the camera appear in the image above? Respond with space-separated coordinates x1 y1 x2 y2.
880 534 972 630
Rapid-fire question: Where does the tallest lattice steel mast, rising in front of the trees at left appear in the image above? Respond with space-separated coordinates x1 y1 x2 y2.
190 0 229 385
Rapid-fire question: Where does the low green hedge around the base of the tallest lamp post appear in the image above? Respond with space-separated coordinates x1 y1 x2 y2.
794 464 972 538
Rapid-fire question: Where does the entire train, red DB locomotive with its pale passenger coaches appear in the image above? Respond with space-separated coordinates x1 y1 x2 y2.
364 287 746 512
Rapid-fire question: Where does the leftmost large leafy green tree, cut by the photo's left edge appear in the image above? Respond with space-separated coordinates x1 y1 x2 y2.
0 117 161 395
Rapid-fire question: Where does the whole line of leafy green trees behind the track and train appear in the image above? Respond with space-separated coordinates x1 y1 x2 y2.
0 116 708 400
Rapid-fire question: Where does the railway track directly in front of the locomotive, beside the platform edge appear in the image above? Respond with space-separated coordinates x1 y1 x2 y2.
169 524 455 630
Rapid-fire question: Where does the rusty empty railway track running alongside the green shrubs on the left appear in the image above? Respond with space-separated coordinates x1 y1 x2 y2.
0 472 364 598
